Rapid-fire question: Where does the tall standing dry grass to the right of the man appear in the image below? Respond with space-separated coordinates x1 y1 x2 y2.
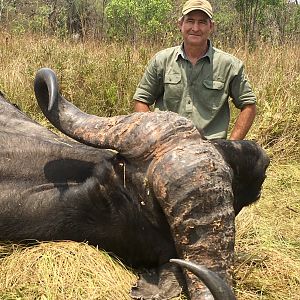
231 42 300 161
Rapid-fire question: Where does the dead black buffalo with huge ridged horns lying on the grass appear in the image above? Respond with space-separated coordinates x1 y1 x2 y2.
0 68 269 300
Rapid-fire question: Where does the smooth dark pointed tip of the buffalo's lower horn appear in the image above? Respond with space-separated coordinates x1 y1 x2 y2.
170 259 236 300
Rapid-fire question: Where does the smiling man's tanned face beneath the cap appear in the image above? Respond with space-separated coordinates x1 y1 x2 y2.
179 10 214 46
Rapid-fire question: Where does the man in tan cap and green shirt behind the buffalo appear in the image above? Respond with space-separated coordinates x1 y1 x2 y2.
133 0 256 140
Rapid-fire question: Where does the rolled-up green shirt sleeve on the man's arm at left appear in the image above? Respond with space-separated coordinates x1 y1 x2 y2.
133 56 163 105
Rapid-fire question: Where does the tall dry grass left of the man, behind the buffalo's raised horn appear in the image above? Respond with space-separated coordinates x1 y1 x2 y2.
0 32 149 116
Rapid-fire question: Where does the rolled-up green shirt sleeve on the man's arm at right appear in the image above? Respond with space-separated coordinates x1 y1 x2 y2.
230 62 256 109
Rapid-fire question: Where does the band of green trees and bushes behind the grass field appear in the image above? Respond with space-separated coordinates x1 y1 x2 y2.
0 0 300 45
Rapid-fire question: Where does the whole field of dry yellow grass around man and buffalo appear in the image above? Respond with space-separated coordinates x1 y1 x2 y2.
0 32 300 300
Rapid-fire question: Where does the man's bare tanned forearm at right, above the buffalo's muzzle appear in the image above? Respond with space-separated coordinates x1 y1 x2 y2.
229 104 256 140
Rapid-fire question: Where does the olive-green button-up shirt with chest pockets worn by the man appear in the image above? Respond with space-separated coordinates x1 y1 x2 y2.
133 43 256 139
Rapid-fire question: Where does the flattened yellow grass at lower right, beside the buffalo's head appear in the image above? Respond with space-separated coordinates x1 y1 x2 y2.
235 163 300 300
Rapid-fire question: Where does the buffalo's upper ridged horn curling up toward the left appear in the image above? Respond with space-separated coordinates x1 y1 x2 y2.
34 68 200 160
